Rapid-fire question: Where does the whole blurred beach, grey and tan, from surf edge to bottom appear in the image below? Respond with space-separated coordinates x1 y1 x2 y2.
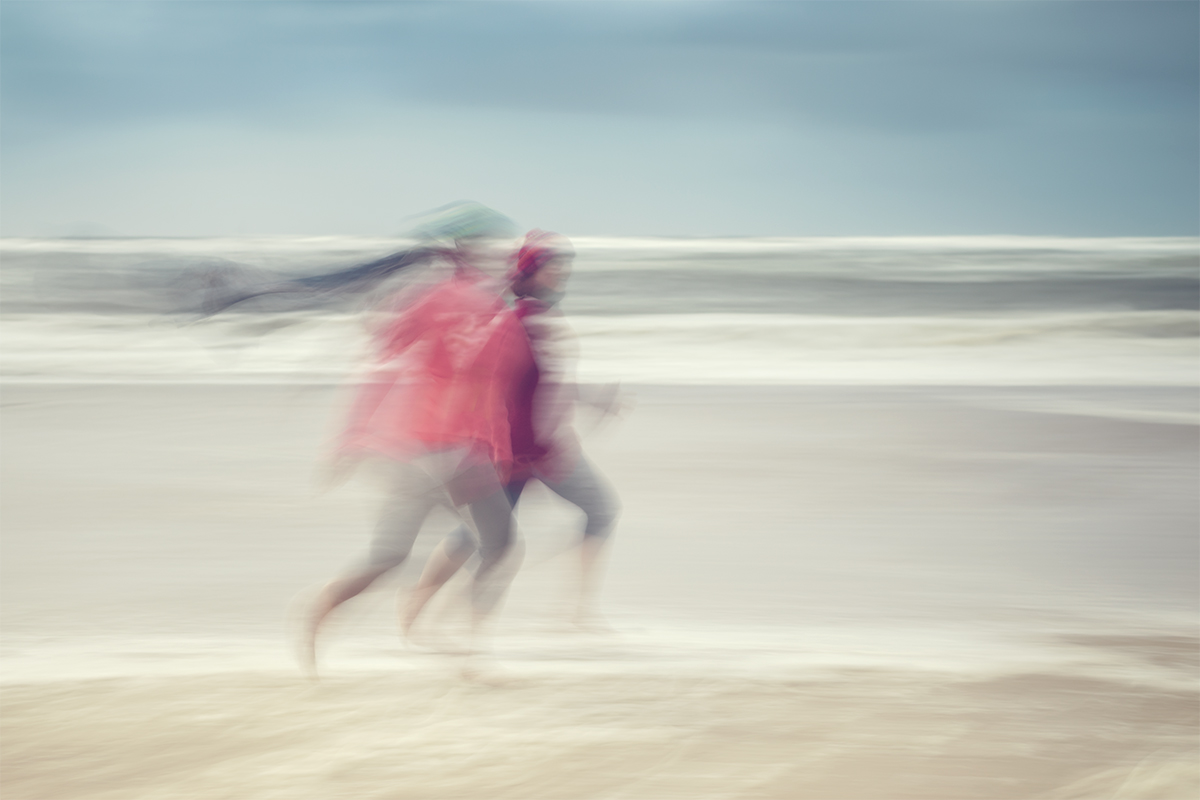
0 386 1200 800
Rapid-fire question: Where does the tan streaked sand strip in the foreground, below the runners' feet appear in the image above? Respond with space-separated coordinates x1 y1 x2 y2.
4 662 1198 800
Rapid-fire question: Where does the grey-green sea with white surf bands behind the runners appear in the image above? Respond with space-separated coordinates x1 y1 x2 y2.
0 236 1200 386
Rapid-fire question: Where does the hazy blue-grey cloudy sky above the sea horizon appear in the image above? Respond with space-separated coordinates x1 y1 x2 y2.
0 0 1200 236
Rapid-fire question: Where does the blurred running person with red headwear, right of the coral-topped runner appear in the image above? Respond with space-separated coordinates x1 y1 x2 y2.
401 230 619 637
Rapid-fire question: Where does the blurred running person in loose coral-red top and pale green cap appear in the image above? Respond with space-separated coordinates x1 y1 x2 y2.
301 204 532 674
